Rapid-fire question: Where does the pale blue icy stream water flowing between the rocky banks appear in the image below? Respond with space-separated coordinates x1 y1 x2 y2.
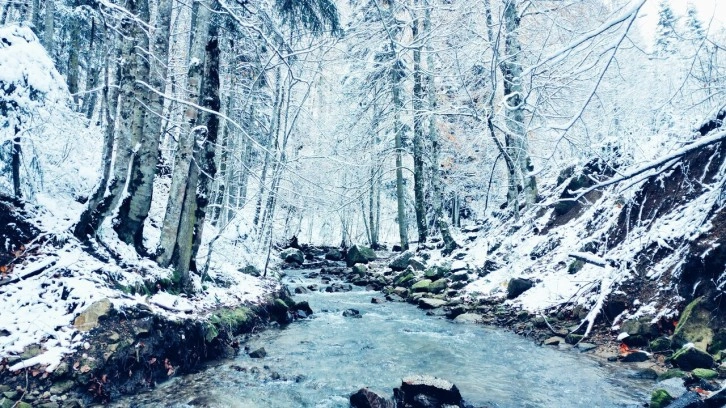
116 271 650 408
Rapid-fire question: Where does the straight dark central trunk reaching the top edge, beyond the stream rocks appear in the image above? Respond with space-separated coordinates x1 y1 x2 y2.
411 0 428 243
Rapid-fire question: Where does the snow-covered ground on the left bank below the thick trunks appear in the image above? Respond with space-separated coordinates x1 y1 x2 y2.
0 197 278 371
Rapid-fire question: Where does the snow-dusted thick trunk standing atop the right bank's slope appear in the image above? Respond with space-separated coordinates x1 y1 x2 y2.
499 0 537 206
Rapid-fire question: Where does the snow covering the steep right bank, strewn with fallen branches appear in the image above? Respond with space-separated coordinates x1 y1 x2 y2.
461 131 726 326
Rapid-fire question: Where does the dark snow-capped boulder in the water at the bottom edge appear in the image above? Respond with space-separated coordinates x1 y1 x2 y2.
393 375 464 407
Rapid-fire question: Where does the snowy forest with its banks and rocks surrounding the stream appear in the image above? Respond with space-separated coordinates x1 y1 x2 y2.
0 0 726 407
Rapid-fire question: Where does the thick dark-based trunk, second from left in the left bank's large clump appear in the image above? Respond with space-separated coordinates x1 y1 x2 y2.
116 0 172 253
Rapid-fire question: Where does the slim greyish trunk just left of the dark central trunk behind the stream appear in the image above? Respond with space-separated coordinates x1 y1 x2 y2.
392 59 408 251
